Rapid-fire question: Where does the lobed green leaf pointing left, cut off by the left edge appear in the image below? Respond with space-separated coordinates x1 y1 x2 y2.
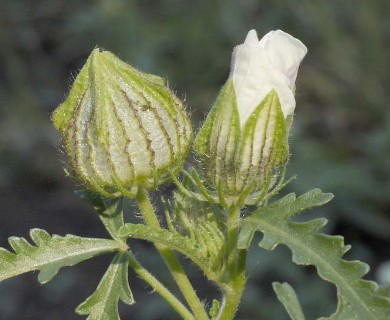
0 229 121 283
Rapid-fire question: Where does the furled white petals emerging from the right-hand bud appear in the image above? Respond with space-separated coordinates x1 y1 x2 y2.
229 30 307 127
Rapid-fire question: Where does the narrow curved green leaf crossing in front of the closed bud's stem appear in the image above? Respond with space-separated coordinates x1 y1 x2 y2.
119 223 218 280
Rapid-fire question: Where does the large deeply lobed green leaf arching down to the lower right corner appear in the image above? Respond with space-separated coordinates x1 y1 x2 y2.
238 189 390 320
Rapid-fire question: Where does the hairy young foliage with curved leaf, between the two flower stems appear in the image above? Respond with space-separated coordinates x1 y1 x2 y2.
118 180 226 280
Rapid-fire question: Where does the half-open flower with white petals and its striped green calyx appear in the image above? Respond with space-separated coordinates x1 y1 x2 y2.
195 30 307 202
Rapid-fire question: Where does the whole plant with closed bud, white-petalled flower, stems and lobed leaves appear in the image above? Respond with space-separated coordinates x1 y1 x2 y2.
0 30 390 320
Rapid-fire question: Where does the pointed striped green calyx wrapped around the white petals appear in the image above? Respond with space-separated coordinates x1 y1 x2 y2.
194 81 289 203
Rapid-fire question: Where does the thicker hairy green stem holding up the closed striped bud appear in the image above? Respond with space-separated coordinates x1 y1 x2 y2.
135 188 209 320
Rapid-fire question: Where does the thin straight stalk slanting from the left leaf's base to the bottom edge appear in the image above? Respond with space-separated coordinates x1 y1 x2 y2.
129 252 195 320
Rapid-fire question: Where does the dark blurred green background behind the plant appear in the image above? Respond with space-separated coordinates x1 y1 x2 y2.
0 0 390 320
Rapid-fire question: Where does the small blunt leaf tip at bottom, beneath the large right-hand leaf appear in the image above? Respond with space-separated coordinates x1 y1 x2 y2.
272 282 305 320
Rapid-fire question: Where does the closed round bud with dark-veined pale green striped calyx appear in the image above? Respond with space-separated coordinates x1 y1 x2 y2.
52 49 192 197
